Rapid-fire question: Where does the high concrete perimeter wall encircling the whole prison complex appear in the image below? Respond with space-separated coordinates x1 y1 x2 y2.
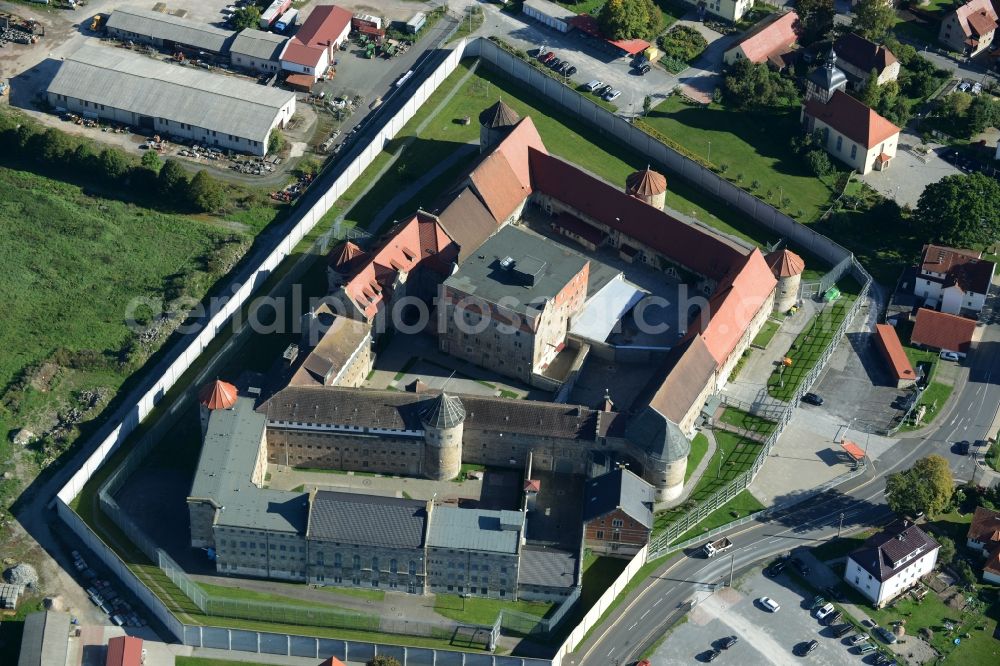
53 39 884 666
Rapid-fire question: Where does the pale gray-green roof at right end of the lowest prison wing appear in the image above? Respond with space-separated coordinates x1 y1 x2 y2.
427 506 524 555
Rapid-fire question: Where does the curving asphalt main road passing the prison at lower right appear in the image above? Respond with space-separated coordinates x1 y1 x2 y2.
576 308 1000 666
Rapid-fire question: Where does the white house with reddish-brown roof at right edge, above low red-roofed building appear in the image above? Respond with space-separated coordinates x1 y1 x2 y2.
913 245 996 315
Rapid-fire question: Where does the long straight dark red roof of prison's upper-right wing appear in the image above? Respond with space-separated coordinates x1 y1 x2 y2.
528 148 748 280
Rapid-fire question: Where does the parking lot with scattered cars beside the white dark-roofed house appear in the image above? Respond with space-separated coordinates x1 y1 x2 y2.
650 570 870 666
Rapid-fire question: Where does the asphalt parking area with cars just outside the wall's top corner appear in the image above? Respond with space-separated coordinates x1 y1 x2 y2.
477 4 677 113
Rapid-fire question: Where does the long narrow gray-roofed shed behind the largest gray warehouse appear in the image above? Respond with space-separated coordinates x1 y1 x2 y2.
106 7 236 54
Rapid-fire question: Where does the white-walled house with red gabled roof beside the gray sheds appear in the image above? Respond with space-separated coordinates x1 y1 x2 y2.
280 5 351 82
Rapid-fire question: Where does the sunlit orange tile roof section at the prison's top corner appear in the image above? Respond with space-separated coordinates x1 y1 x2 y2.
469 118 547 222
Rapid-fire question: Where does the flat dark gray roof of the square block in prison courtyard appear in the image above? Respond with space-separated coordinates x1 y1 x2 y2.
445 226 588 316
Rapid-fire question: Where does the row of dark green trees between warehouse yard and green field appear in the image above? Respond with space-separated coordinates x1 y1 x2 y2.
0 120 228 212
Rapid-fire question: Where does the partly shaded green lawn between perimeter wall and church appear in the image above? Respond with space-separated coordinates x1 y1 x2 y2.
645 95 832 222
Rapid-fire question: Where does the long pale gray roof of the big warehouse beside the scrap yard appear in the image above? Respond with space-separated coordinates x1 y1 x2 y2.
48 45 295 142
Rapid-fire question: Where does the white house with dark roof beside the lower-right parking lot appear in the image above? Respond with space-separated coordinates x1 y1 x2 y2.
844 519 941 608
